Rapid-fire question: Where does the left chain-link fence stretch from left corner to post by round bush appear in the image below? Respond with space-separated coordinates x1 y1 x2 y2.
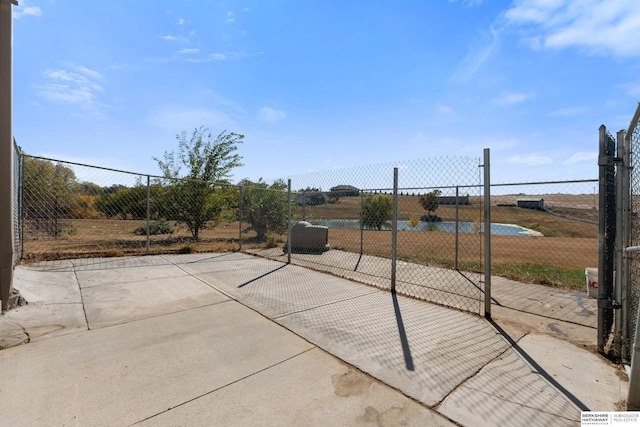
17 155 276 261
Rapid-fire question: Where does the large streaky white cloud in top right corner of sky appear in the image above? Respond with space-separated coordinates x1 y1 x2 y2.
504 0 640 56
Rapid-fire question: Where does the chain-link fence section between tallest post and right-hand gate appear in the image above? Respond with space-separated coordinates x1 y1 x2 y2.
491 179 599 290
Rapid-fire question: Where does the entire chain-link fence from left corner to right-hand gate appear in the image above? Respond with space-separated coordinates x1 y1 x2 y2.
16 148 599 320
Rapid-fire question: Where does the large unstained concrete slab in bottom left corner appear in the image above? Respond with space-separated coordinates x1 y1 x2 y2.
0 302 313 426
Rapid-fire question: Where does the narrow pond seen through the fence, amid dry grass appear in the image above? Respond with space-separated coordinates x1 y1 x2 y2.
310 219 543 236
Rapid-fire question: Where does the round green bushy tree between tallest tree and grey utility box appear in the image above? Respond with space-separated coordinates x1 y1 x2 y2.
240 179 289 242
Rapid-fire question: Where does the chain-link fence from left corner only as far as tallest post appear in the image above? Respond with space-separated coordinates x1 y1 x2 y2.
19 155 490 318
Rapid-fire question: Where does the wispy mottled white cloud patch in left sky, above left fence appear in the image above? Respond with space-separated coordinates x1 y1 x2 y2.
34 65 104 110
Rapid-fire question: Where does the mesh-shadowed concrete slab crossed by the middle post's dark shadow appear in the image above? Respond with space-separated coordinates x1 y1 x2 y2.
276 291 509 406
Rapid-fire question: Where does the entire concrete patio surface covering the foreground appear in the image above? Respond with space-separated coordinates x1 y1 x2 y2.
0 253 626 426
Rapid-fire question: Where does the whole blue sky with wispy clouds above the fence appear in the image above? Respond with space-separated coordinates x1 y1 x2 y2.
13 0 640 183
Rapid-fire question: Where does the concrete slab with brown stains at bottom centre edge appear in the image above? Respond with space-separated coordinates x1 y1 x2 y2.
140 348 455 426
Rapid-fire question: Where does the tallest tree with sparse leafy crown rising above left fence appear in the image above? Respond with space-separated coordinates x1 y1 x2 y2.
154 126 244 241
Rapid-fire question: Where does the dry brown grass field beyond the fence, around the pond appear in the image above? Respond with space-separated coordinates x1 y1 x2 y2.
23 194 598 289
